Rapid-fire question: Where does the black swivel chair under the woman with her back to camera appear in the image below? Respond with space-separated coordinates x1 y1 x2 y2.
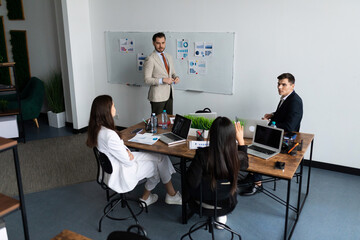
181 180 241 240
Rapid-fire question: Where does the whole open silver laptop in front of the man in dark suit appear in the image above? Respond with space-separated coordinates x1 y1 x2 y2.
248 125 284 159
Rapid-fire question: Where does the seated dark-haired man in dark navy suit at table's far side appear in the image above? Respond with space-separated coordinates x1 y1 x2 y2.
240 73 303 196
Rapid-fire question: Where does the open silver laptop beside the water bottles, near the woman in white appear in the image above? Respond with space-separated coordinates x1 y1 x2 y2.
159 114 191 146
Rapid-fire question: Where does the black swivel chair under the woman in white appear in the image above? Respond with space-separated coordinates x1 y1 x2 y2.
93 147 148 232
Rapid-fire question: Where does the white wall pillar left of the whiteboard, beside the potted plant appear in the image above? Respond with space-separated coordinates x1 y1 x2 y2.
61 0 95 129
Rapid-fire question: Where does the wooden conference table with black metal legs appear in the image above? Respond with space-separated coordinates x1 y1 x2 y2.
120 122 314 239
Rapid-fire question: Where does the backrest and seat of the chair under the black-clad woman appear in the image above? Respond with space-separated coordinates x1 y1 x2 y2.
190 179 237 217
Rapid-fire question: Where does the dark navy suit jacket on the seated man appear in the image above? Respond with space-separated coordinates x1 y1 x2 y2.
269 91 303 132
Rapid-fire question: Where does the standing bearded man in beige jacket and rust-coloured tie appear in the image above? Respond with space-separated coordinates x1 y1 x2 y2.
144 32 180 115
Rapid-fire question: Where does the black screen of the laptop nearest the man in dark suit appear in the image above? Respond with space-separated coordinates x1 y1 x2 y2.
254 125 282 149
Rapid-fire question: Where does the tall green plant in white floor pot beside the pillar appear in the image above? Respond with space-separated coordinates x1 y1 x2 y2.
45 72 65 128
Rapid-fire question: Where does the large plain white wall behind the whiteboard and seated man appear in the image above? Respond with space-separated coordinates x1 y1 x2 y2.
62 0 360 168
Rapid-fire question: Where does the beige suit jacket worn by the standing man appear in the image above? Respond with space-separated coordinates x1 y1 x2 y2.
144 50 177 102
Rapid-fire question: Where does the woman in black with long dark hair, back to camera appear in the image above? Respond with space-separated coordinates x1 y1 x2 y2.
186 117 248 227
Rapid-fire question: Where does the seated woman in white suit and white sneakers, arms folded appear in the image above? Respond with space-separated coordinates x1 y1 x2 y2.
86 95 182 206
